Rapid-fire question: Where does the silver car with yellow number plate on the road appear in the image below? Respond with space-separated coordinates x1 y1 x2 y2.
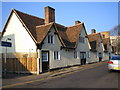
108 55 120 71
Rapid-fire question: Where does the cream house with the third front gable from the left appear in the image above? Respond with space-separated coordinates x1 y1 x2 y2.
88 29 104 62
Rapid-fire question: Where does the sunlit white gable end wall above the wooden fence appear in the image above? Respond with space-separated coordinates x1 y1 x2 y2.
2 13 36 53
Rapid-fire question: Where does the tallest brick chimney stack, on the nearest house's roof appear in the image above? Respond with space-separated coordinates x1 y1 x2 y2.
45 6 55 24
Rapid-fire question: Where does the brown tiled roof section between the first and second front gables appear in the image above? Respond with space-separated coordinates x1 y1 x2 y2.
56 23 83 48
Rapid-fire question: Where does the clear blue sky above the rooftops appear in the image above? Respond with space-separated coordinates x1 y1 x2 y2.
0 2 118 34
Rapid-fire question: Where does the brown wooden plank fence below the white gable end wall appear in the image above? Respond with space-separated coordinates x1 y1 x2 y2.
2 52 37 73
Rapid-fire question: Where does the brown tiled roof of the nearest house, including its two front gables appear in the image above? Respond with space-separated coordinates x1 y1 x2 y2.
3 9 85 48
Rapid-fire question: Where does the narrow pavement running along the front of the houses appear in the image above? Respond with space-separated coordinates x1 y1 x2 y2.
0 61 107 88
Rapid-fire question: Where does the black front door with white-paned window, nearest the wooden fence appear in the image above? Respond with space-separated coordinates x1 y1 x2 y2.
42 51 49 72
